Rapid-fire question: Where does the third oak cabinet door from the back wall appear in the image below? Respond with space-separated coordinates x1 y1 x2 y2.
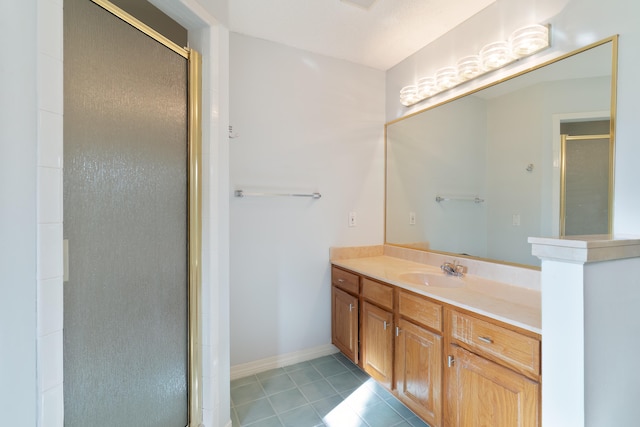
395 319 442 426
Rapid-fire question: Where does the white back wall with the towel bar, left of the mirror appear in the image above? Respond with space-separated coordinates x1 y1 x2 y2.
229 33 384 365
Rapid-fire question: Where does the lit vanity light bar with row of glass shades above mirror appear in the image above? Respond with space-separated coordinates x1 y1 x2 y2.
400 24 549 107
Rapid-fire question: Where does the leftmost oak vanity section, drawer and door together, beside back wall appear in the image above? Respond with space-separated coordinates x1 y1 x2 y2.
331 267 360 364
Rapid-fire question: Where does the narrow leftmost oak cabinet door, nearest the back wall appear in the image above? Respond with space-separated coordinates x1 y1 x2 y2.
331 286 358 363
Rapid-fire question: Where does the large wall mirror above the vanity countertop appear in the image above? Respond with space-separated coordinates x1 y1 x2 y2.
385 36 617 267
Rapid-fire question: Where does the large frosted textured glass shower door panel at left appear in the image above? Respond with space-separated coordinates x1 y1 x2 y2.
63 0 189 427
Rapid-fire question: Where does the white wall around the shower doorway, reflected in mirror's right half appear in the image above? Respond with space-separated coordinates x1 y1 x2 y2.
487 77 611 265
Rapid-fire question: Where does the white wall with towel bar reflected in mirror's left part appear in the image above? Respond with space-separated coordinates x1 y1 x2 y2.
386 97 487 257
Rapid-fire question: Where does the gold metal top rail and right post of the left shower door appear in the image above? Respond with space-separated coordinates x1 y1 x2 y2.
91 0 202 427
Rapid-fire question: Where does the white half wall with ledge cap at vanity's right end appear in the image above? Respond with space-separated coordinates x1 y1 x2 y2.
533 239 640 427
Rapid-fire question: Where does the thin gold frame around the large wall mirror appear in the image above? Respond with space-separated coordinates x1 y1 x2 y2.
384 34 619 270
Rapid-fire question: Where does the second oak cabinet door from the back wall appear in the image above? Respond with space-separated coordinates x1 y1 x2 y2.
361 302 394 389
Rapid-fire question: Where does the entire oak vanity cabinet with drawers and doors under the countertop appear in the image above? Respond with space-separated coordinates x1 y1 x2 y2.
331 266 541 427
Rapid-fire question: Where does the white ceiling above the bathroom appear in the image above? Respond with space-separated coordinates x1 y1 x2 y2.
229 0 495 70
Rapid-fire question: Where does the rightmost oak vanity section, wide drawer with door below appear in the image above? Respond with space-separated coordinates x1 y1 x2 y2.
445 310 540 427
